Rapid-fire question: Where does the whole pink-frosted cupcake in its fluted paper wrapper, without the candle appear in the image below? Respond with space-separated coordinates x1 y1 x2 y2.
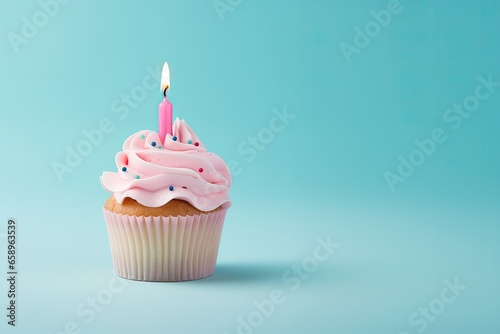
100 119 231 281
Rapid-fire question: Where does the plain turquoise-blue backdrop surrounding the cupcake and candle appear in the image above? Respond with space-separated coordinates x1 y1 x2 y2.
0 0 500 334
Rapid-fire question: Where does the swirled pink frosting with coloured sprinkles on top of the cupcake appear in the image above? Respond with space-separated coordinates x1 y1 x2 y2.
100 119 231 211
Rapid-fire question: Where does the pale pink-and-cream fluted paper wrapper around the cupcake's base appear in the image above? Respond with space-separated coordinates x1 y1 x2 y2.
103 209 227 281
